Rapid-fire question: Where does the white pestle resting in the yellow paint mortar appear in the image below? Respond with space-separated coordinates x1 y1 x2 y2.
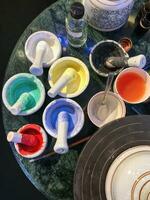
47 68 77 98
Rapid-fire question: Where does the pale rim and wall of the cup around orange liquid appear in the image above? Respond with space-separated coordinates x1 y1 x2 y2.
114 67 150 104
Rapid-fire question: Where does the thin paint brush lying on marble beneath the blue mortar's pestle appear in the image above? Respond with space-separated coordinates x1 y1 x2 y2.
29 136 92 163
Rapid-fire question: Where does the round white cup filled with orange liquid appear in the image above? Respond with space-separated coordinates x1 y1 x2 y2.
114 67 150 104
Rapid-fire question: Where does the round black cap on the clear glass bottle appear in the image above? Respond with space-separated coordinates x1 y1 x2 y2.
70 2 84 19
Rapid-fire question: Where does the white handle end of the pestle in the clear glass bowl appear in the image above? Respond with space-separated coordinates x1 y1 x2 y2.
127 54 146 68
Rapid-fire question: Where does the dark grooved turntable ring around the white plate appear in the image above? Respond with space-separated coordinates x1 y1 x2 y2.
74 115 150 200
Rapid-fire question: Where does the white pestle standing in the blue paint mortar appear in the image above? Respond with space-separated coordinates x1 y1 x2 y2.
54 111 69 154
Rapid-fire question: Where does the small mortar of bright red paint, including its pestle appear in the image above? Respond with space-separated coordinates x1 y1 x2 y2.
7 124 47 158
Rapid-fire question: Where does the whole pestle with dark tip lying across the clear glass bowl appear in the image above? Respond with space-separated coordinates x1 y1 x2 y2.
105 54 146 69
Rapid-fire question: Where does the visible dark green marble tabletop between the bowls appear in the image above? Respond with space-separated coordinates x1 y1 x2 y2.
2 0 150 200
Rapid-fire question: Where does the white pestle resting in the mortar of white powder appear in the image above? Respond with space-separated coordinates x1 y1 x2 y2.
29 41 49 76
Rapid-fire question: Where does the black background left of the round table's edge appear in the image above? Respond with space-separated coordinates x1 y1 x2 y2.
0 0 56 200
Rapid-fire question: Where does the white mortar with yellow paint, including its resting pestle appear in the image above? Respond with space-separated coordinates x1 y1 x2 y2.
48 57 90 98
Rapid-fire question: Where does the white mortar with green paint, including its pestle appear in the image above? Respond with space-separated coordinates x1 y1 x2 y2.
2 73 45 115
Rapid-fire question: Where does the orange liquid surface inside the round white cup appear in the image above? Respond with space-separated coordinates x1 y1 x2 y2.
116 72 146 102
